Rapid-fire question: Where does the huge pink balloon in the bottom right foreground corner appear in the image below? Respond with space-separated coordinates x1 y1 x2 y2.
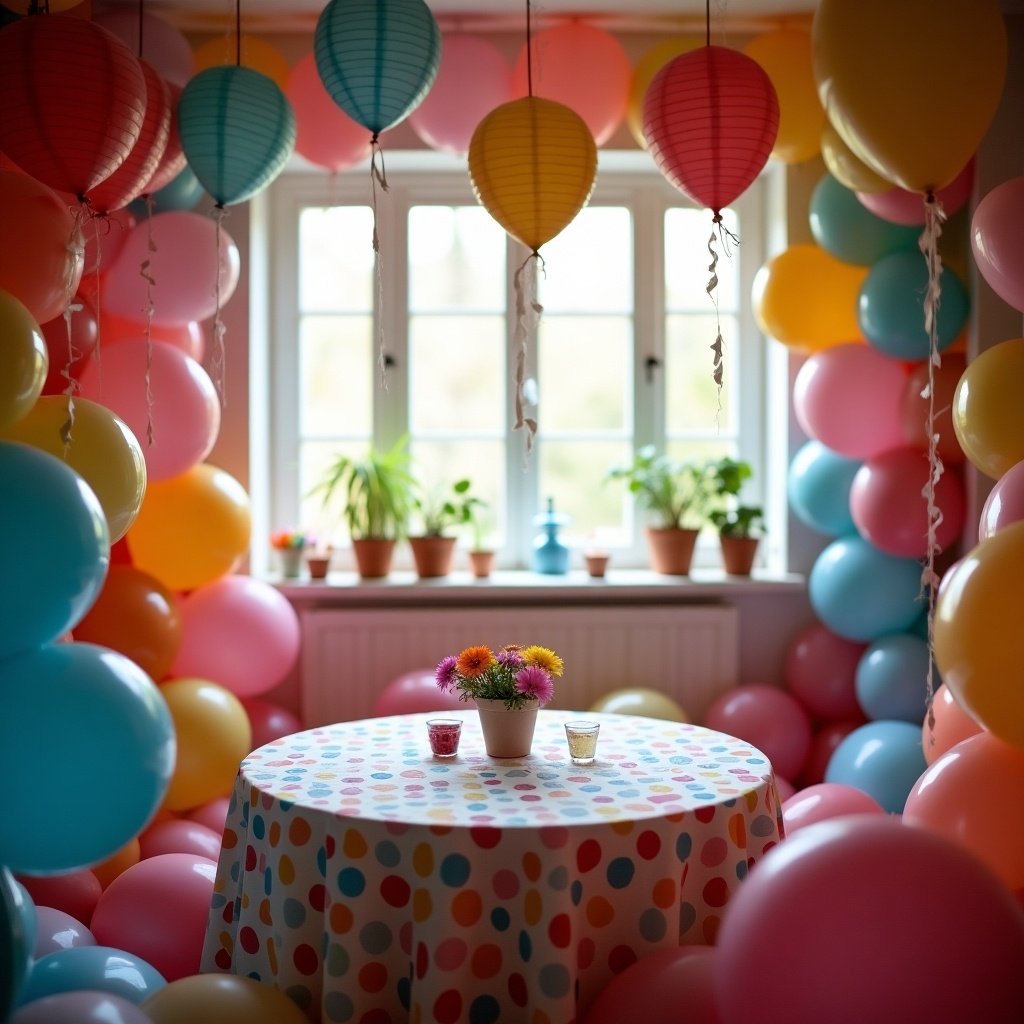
715 815 1024 1024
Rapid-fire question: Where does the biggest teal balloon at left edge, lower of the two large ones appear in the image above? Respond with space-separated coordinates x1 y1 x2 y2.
0 643 176 876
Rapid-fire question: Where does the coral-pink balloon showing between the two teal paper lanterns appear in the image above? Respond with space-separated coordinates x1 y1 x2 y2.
285 52 371 171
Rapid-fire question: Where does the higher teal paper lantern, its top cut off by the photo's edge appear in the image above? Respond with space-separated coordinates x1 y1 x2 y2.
313 0 441 137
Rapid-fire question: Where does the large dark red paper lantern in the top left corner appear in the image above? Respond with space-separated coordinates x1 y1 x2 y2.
0 14 145 199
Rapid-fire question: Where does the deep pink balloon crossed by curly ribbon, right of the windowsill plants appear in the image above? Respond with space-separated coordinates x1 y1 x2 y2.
850 447 967 558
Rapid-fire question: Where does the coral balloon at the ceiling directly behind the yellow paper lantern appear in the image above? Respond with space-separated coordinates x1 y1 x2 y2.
512 20 633 145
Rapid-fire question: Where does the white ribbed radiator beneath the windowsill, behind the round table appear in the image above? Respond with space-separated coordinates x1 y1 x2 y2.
300 604 739 727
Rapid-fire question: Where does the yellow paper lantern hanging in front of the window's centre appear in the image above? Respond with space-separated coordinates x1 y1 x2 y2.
468 96 597 252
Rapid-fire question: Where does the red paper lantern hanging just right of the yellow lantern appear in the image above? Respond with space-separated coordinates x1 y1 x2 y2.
643 46 778 216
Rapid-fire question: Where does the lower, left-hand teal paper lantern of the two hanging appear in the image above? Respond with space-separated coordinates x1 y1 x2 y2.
178 65 296 207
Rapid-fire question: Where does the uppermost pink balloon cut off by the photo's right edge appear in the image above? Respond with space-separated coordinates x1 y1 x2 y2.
971 177 1024 312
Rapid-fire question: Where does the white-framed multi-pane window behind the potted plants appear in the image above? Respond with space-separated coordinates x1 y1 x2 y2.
267 153 765 568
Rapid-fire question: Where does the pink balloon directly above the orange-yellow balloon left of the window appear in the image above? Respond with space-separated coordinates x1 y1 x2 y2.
79 341 220 480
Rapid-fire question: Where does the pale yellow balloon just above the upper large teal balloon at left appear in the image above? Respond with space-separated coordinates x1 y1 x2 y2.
0 394 146 544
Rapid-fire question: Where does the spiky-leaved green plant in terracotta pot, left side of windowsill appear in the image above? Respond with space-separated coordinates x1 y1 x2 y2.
313 437 415 580
